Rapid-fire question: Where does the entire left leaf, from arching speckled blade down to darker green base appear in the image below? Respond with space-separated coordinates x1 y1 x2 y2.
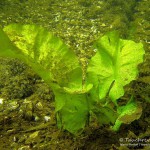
0 24 92 134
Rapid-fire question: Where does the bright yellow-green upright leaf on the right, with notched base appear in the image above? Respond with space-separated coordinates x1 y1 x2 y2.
87 32 144 103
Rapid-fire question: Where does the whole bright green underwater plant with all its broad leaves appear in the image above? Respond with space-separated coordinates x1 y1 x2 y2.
0 24 145 134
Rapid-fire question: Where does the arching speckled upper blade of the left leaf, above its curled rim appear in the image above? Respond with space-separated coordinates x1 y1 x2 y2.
0 24 82 89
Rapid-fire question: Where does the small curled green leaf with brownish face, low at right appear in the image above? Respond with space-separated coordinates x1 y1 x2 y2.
112 97 142 131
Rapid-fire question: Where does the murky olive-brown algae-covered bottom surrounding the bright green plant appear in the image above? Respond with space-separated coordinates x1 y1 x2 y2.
0 0 150 150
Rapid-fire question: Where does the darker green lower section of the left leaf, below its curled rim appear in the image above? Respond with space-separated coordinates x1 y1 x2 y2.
54 89 89 134
